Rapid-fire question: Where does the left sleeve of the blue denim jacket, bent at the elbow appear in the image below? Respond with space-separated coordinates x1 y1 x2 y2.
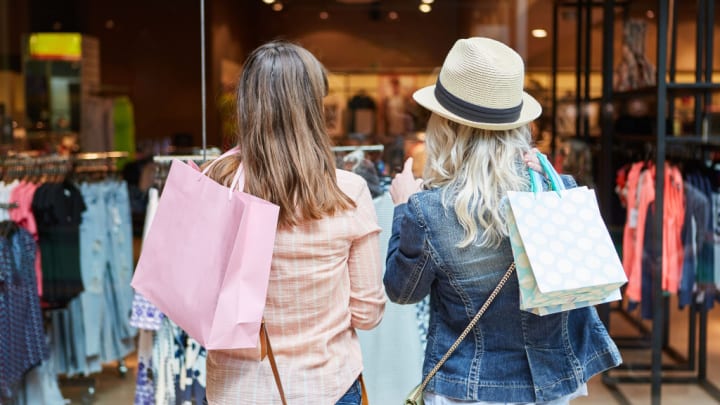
383 197 435 304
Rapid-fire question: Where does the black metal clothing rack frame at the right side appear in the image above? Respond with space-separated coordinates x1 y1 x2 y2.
552 0 720 405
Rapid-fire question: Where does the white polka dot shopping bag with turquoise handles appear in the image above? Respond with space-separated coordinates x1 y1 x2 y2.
508 154 627 315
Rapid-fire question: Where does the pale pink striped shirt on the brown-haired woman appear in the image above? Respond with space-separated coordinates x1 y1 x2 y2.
207 170 386 405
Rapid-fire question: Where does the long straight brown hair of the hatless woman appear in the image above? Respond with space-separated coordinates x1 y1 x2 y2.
204 41 355 227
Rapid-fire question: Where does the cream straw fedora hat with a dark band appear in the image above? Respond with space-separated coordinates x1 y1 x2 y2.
413 37 542 130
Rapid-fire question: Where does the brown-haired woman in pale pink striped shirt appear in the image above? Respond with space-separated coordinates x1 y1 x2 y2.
202 41 385 405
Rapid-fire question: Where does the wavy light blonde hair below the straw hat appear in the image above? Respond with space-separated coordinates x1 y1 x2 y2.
424 114 530 247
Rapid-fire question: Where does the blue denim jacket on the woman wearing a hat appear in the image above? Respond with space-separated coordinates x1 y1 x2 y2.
384 176 622 403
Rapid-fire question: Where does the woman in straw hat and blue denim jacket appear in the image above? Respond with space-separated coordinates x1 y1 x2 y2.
384 38 621 405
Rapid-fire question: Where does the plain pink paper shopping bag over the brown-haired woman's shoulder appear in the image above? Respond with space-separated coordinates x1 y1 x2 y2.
131 151 279 349
